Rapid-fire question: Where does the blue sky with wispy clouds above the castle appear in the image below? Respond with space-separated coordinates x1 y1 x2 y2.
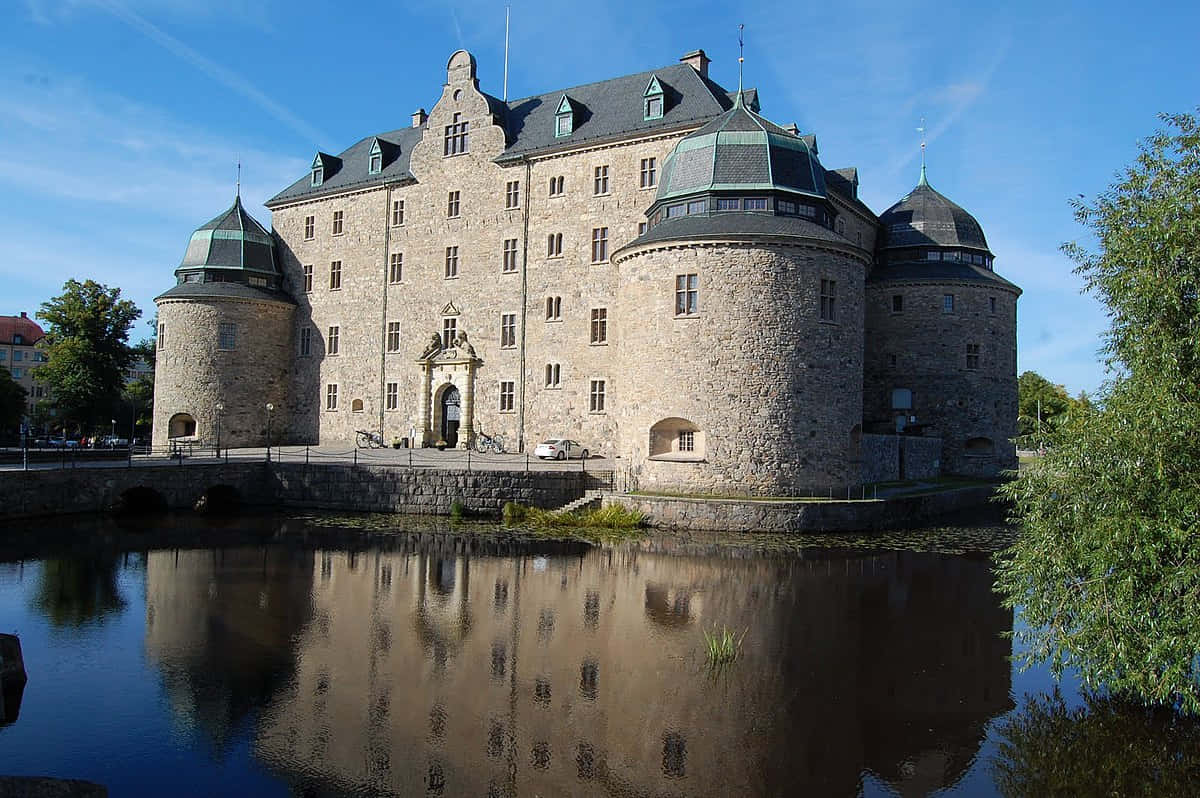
0 0 1200 394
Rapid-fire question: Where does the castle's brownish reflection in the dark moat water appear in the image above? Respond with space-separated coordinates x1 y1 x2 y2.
145 525 1013 796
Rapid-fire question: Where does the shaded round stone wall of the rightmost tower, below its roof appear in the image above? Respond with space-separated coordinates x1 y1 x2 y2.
863 281 1018 475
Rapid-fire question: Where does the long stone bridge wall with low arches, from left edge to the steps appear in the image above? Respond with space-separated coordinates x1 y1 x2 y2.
0 461 611 520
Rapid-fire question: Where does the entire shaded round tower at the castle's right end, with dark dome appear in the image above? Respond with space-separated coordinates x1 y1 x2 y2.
864 167 1021 476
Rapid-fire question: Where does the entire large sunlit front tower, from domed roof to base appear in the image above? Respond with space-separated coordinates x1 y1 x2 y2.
613 95 870 496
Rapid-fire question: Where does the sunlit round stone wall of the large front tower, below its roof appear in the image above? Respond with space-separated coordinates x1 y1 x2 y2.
614 239 866 496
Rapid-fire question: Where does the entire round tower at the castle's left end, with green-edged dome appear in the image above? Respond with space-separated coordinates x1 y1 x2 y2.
152 197 295 446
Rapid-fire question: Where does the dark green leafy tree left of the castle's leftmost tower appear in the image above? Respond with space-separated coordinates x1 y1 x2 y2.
35 280 142 427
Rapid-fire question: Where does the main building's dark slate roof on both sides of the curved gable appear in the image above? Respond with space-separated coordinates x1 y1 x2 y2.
265 64 744 208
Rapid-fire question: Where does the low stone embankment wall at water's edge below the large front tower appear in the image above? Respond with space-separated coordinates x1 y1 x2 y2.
604 486 995 533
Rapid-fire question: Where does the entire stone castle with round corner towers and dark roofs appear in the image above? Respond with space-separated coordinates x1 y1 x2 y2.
147 50 1020 496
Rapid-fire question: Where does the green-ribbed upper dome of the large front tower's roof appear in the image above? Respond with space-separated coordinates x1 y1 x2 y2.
654 101 826 204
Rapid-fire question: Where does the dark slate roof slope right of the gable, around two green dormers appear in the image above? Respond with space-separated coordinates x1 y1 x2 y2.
498 64 730 162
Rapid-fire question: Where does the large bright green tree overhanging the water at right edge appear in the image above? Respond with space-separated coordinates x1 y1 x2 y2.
997 114 1200 713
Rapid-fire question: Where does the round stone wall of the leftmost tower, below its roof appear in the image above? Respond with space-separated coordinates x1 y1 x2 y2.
151 298 294 446
